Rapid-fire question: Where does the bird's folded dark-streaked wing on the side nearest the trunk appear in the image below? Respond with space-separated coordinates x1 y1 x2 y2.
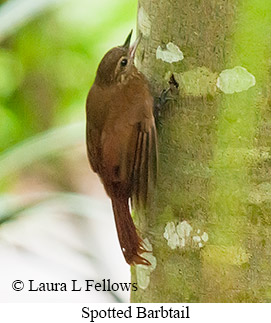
132 118 157 209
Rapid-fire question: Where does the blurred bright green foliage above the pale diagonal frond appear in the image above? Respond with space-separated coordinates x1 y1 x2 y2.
0 0 136 151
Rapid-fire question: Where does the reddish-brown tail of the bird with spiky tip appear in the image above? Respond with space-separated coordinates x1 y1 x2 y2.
112 197 150 265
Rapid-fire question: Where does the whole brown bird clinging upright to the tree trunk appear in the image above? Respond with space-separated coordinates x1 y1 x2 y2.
86 31 157 265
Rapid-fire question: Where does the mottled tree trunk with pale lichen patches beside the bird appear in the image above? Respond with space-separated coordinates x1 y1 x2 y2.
131 0 271 302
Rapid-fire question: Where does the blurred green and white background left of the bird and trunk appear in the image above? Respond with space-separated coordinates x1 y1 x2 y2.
0 0 137 301
